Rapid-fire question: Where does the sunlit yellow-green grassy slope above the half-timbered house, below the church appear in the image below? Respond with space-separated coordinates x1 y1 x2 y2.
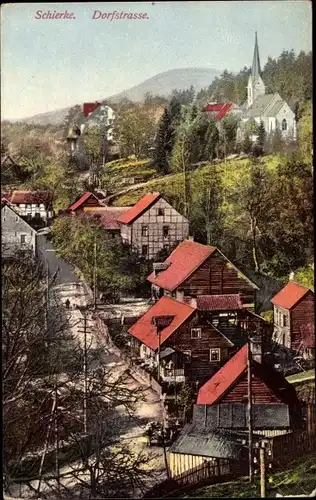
114 156 280 206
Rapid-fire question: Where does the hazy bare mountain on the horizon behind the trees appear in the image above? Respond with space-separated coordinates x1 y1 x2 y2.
16 68 220 125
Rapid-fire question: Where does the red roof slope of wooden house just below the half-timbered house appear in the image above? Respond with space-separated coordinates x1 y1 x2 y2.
147 240 216 292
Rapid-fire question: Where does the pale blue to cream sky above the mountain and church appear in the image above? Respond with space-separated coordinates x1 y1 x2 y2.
1 0 312 119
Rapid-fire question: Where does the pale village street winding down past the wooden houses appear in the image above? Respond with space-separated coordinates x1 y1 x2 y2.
30 236 165 496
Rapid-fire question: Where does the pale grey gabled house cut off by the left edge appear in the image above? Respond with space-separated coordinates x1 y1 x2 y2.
1 204 37 257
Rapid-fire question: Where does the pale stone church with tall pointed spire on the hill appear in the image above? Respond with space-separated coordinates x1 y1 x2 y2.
236 32 297 142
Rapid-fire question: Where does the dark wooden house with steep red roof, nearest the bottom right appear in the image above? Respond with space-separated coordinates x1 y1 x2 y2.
196 340 302 435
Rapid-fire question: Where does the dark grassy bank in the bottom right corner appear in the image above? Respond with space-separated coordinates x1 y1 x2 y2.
178 455 316 498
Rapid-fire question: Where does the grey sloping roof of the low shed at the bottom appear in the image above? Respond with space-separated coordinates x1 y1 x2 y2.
168 424 245 460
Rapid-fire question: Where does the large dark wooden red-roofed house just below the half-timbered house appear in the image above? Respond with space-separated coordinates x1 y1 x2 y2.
147 240 258 309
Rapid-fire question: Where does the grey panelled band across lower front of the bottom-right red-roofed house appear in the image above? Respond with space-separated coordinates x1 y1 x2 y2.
193 403 290 430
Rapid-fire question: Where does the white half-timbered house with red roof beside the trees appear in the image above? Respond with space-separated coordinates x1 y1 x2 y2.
118 193 189 259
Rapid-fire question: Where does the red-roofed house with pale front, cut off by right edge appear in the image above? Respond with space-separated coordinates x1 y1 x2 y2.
271 281 315 358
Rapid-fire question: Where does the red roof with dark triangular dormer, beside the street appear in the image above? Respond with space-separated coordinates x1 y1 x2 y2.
128 296 196 350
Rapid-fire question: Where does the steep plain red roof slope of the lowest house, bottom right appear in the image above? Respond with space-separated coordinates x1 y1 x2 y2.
197 344 248 405
